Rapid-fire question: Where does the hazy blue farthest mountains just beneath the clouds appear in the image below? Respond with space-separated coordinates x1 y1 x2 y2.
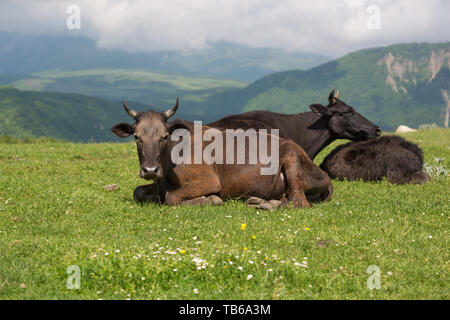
0 32 330 82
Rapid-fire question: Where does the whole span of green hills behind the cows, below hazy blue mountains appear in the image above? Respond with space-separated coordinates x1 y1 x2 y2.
0 42 450 142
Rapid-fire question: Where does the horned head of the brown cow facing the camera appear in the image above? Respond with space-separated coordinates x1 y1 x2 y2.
111 98 183 180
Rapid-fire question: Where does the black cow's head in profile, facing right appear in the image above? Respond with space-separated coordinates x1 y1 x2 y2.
309 89 381 141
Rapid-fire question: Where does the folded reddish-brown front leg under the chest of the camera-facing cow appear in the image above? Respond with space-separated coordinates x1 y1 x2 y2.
165 166 222 205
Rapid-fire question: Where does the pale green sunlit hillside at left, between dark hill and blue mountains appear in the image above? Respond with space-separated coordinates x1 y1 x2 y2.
0 69 246 105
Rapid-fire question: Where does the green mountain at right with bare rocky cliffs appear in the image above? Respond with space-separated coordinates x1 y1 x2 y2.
184 42 450 130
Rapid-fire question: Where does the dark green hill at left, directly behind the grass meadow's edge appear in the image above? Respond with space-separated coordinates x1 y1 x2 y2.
0 87 192 142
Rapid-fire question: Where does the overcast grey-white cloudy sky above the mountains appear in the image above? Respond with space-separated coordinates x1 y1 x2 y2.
0 0 450 57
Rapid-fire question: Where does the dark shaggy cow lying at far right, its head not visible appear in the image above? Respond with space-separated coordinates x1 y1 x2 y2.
320 136 430 184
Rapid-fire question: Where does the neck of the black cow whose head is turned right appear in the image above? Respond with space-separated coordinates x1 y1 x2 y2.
290 112 336 159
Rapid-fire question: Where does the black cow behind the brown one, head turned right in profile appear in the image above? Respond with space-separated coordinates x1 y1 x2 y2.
207 89 381 159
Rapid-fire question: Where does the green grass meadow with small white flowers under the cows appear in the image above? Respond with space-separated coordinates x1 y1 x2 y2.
0 129 450 299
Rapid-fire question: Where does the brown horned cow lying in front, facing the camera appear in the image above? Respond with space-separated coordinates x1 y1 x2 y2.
111 100 332 209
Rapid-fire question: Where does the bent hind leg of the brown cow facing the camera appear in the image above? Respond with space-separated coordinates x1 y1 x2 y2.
280 148 311 208
